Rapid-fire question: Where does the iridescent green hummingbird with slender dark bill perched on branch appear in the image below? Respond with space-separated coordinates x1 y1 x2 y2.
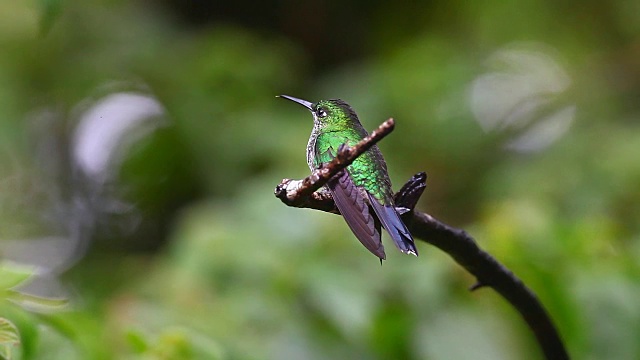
280 95 418 262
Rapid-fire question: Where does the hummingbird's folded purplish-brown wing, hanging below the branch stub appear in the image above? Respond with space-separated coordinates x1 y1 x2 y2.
327 170 386 260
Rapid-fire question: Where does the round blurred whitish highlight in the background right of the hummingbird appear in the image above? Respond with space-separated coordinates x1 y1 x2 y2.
470 44 576 152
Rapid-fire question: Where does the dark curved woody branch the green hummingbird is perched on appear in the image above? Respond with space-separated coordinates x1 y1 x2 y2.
275 119 569 359
